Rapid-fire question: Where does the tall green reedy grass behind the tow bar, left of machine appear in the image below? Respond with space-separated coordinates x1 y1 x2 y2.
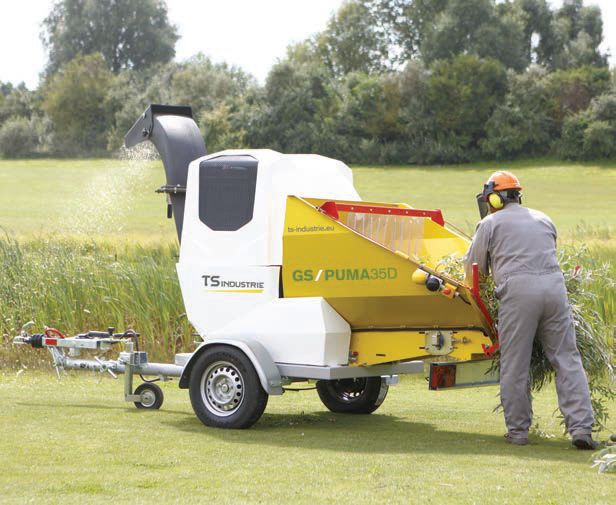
0 237 193 366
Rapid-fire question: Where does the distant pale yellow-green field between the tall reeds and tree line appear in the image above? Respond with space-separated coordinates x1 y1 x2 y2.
0 160 616 242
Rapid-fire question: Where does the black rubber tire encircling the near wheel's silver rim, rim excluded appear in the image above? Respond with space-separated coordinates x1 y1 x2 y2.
188 345 269 429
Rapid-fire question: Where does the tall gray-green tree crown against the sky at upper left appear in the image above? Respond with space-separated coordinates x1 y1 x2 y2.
41 0 178 75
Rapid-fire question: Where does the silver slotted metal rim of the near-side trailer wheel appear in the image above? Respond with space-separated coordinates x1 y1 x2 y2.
201 361 244 417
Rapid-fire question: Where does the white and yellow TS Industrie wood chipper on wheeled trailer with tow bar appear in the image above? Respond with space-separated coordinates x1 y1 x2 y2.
16 105 498 428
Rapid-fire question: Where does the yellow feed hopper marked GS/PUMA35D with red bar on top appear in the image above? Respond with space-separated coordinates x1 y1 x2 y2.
282 196 494 365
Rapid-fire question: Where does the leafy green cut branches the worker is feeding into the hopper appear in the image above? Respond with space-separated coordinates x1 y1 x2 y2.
438 248 616 430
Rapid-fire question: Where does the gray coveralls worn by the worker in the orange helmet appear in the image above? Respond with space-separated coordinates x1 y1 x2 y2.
465 203 593 438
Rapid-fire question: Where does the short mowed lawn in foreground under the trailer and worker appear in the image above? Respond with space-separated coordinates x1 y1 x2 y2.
0 370 616 505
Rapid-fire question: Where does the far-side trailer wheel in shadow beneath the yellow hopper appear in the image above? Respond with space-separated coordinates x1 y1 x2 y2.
317 377 389 414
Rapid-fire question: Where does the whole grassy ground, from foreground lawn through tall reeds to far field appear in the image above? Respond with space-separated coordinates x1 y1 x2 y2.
0 160 616 505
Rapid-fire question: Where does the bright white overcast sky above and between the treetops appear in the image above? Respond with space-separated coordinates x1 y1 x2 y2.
0 0 616 88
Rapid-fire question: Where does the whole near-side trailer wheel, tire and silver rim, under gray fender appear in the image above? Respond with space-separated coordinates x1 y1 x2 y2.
188 346 268 429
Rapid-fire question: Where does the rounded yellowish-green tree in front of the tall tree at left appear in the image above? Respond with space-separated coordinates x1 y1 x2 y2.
42 53 113 155
